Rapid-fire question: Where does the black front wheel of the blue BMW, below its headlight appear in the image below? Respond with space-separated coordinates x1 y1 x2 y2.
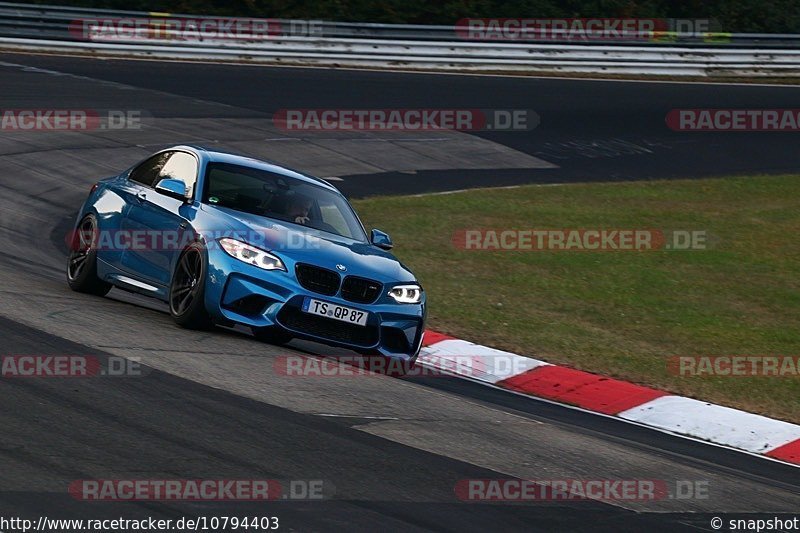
169 243 214 330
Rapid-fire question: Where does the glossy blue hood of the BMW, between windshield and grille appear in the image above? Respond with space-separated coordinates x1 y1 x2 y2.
201 204 415 283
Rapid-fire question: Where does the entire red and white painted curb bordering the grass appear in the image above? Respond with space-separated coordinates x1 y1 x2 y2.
418 331 800 465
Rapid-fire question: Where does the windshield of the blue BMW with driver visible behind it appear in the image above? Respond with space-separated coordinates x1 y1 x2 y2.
203 159 366 242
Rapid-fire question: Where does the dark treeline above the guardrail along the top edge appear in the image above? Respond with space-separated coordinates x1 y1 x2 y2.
21 0 800 33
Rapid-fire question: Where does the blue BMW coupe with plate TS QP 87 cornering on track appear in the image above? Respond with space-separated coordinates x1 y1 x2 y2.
67 146 426 366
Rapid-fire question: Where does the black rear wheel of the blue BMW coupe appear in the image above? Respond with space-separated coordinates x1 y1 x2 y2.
67 215 112 296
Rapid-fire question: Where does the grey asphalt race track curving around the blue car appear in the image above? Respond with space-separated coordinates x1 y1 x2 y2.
0 54 800 531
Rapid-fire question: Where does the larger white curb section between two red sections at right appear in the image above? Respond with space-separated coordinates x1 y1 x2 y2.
618 396 800 453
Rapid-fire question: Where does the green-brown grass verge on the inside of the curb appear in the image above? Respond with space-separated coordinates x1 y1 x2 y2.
354 176 800 423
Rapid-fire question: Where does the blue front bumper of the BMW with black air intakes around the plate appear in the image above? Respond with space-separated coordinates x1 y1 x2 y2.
206 250 426 361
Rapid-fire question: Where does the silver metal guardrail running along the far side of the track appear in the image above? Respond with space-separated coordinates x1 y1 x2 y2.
0 2 800 77
